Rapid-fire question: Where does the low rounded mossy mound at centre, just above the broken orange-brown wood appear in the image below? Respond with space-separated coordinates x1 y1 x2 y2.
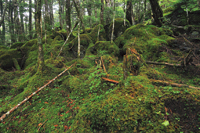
86 41 119 56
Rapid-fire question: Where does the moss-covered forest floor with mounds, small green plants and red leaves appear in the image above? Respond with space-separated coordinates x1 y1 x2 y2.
0 19 200 133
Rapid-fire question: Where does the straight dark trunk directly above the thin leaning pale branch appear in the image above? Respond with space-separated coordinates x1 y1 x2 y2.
66 0 71 35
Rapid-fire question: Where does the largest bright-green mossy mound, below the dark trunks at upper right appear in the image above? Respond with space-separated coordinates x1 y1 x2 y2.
115 24 174 60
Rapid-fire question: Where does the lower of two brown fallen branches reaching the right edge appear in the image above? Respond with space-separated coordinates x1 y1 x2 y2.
150 79 200 90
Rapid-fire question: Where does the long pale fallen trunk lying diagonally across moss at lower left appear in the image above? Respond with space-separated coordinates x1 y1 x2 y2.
0 63 76 121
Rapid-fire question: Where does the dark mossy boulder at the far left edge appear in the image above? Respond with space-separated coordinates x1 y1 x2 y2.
0 49 23 70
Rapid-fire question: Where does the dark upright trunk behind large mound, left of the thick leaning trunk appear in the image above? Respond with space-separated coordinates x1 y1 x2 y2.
126 0 133 25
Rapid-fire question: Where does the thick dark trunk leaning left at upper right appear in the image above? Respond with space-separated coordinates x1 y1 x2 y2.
149 0 163 27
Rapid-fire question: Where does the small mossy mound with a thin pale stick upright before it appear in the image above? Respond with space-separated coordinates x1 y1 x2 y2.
89 24 106 43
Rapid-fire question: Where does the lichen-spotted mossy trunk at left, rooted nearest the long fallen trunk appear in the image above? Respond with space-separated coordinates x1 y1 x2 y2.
36 0 44 72
